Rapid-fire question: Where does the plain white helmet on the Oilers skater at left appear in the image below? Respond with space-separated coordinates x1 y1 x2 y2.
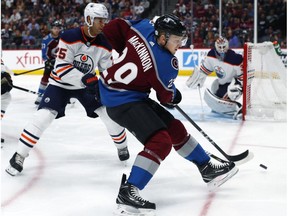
84 3 109 27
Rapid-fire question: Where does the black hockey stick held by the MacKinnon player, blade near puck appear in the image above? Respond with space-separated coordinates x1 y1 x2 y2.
175 105 252 162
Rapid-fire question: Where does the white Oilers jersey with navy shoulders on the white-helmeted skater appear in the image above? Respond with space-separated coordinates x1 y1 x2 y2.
49 27 112 90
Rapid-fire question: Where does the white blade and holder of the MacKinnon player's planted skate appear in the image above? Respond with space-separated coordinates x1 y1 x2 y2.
113 204 156 216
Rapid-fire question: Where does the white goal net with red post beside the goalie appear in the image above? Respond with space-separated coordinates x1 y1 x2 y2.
242 42 287 121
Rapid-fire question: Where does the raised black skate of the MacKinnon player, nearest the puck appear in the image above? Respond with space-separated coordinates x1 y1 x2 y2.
198 160 238 191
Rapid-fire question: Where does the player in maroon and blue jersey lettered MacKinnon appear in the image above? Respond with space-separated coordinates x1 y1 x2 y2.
99 15 238 215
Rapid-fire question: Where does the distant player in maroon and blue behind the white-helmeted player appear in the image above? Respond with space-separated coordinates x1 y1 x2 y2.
35 20 62 105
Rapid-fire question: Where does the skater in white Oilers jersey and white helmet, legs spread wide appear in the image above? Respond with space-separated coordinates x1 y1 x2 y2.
6 3 129 176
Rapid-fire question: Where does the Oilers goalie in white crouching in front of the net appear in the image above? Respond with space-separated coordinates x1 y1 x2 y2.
186 36 243 119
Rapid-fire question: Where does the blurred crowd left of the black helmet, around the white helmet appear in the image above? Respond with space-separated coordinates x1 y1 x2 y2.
1 0 150 49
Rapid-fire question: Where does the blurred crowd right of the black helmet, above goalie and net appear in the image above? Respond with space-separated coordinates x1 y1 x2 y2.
173 0 287 48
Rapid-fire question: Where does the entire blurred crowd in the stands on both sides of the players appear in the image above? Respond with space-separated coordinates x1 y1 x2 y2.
1 0 287 49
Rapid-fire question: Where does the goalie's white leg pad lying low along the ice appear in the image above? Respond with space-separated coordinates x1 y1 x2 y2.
204 89 241 115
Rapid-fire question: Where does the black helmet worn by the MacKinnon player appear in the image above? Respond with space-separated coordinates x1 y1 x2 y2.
154 14 187 46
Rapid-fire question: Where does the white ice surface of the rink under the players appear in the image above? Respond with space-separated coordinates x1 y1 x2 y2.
1 75 287 216
